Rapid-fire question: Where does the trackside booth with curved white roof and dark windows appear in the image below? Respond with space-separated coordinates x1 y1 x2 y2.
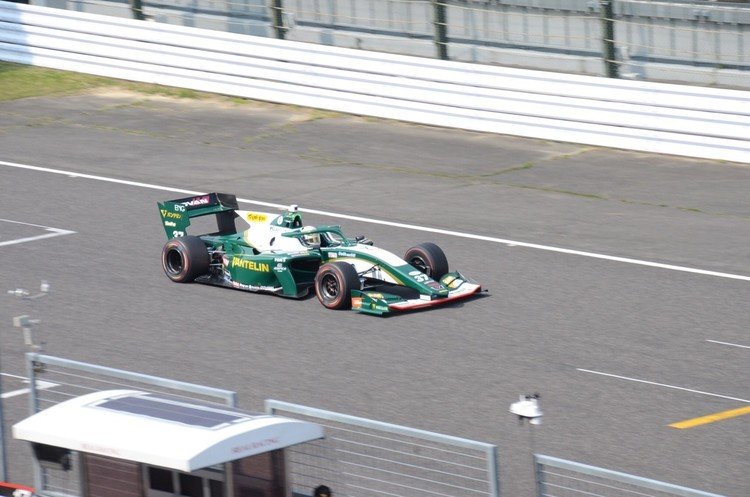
13 390 324 497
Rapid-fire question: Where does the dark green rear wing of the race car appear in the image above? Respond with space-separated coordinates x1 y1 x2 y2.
158 193 239 238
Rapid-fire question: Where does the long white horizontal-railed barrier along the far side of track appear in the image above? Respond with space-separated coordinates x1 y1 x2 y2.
0 1 750 163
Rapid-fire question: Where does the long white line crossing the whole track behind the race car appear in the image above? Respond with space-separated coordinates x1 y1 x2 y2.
0 161 750 281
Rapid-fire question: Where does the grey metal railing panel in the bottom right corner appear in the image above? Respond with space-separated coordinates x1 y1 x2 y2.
534 455 722 497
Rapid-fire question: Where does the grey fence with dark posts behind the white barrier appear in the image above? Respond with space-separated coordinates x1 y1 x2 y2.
33 0 750 90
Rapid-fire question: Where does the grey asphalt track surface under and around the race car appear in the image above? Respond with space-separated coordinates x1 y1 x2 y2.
0 92 750 497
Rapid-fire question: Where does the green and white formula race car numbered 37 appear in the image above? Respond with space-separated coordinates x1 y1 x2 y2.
158 193 481 315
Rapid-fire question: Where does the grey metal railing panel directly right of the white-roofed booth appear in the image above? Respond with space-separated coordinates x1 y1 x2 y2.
266 400 500 497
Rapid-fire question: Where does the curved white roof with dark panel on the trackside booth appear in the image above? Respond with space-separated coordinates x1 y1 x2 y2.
13 390 323 472
